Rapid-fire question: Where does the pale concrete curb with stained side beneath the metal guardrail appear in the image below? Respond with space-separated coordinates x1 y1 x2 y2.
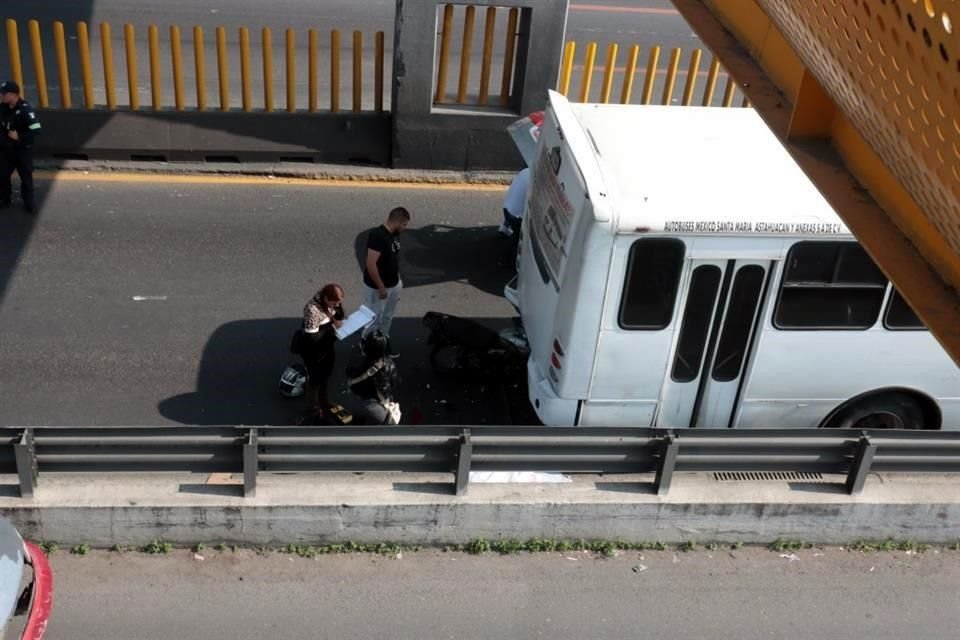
0 474 960 547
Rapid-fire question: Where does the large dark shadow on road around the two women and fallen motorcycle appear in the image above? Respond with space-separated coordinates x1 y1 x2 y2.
158 317 526 425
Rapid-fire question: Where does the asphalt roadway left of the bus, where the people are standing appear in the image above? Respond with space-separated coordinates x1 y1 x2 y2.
0 174 529 426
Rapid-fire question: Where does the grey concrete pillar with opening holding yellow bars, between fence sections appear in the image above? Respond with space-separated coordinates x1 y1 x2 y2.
392 0 568 170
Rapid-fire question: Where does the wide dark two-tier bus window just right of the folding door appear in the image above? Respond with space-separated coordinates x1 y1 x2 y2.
773 241 887 329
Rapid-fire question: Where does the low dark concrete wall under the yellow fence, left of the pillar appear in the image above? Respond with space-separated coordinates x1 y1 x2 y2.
37 109 391 166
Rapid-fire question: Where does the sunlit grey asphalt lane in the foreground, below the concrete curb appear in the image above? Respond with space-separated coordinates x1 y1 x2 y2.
20 548 960 640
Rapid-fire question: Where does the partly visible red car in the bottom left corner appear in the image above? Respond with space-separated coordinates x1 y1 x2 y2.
0 518 53 640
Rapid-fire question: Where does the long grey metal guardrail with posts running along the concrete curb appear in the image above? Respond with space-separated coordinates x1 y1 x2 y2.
0 426 960 498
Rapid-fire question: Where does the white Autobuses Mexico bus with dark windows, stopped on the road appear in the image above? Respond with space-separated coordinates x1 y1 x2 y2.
505 92 960 429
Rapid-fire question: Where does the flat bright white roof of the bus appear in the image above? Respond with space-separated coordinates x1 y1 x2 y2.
550 92 850 236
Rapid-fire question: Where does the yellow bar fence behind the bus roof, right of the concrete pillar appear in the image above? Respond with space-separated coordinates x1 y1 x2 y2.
557 42 750 107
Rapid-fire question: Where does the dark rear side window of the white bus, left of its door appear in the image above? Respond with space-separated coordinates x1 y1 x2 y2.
619 238 685 330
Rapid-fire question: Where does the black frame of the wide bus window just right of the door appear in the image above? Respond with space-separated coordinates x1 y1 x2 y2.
771 240 889 331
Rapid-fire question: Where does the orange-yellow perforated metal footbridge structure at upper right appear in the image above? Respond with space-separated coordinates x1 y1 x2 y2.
673 0 960 364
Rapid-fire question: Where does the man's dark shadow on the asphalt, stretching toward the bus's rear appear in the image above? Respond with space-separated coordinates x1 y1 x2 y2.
353 220 514 296
